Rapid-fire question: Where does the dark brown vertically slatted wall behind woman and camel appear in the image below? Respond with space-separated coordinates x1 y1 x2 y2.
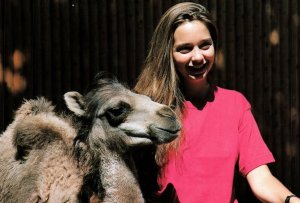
0 0 300 202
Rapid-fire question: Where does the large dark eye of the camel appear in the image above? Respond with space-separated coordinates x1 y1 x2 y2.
106 102 131 126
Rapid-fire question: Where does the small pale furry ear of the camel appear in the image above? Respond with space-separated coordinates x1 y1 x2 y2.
64 92 85 116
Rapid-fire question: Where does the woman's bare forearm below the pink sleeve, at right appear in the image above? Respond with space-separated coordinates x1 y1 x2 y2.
246 165 300 203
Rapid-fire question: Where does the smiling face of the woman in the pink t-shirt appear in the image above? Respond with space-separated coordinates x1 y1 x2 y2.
173 20 215 84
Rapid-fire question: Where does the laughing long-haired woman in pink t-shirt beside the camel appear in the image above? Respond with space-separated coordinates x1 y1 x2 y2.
135 2 300 203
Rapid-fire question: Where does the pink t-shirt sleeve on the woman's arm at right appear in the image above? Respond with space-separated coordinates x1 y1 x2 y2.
238 97 275 176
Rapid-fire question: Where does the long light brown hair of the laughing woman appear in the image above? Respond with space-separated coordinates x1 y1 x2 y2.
134 2 217 166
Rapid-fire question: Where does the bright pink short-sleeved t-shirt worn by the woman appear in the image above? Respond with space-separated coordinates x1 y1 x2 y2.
158 87 274 203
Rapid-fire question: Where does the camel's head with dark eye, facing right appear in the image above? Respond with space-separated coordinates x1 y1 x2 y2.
64 75 180 146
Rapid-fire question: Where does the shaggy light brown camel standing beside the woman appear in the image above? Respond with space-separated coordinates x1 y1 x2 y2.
0 77 180 203
